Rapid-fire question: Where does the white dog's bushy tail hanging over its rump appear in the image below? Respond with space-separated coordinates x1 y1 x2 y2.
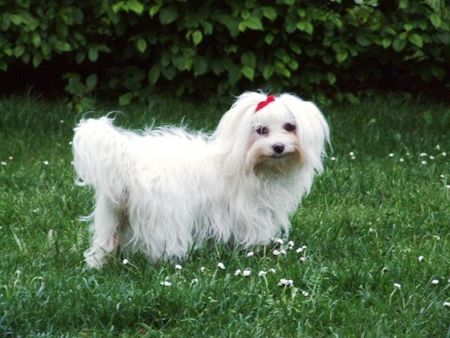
72 117 129 202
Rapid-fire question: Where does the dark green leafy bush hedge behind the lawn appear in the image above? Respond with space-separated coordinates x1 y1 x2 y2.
0 0 450 105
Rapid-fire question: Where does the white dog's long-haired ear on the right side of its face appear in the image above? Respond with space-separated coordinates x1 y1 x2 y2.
279 94 330 172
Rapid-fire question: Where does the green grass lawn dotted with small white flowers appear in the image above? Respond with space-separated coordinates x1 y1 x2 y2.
0 95 450 337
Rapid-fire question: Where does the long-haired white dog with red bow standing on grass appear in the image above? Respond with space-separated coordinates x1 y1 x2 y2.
73 92 329 268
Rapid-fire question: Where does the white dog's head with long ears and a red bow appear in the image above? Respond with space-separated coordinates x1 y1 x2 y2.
213 92 329 178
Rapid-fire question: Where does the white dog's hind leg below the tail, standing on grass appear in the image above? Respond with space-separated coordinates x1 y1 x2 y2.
84 196 123 269
